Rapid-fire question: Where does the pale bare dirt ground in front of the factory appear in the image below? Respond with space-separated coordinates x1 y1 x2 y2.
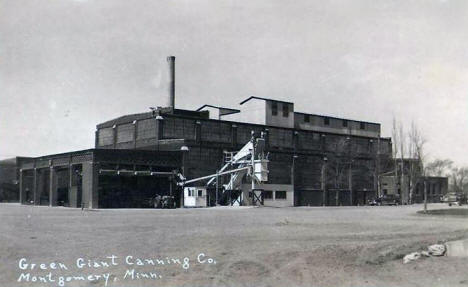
0 204 468 287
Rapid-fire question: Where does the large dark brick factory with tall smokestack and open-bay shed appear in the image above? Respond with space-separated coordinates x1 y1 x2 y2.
20 57 391 208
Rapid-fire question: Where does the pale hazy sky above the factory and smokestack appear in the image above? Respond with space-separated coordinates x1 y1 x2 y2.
0 0 468 165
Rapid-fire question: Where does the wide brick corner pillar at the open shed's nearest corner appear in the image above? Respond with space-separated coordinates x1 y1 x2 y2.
82 162 99 208
